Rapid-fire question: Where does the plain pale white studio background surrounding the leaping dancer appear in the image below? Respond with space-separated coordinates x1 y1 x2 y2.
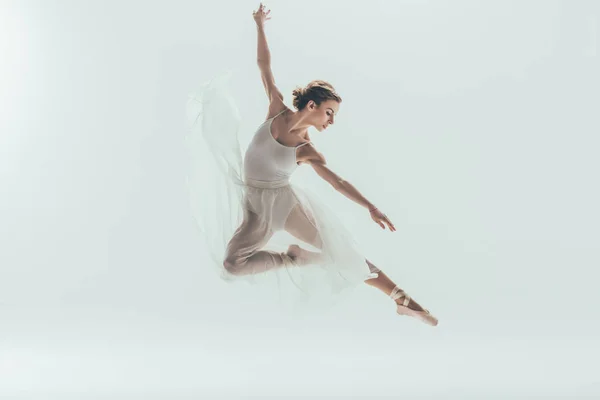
0 0 600 399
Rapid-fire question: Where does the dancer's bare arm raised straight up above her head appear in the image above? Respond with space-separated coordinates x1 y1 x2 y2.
252 3 283 108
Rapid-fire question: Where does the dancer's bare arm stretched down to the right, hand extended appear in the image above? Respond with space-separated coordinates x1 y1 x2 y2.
296 143 396 232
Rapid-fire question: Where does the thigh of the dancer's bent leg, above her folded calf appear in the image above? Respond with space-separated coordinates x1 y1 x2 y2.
226 209 273 258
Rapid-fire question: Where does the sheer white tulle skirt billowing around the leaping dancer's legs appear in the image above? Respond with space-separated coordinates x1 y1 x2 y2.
186 74 378 305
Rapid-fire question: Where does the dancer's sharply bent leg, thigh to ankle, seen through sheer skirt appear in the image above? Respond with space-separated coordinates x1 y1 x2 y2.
223 209 293 275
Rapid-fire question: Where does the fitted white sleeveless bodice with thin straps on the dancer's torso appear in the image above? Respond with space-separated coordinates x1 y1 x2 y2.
244 110 308 182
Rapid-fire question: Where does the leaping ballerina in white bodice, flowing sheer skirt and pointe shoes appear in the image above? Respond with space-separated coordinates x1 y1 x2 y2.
188 3 438 326
